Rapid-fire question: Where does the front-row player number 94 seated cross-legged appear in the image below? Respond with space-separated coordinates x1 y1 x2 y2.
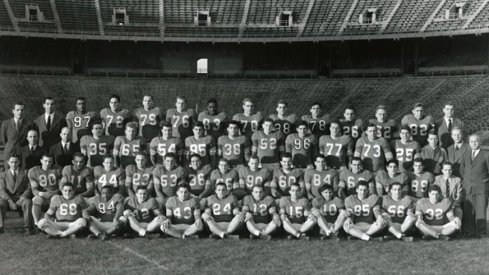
82 185 124 241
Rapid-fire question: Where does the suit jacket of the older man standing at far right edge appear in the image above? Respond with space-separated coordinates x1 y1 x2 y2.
460 149 489 194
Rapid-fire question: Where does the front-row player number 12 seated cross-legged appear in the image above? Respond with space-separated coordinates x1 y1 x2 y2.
242 185 282 240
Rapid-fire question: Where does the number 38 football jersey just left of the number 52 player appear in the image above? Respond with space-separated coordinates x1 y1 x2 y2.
217 136 250 166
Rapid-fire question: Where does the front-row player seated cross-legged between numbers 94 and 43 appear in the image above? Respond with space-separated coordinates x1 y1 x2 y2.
123 185 166 237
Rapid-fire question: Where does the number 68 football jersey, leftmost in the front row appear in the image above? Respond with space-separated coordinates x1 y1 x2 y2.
49 195 87 222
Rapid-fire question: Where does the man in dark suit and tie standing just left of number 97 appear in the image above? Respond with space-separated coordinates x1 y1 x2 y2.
34 97 66 149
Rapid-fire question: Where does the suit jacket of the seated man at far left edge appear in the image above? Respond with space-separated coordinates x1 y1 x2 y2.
0 169 32 202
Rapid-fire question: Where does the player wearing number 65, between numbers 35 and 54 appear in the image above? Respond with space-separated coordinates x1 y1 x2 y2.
112 122 147 168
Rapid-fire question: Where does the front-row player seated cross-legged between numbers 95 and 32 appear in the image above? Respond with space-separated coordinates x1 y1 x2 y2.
382 182 416 241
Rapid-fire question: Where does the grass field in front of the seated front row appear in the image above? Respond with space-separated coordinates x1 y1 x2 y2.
0 218 489 274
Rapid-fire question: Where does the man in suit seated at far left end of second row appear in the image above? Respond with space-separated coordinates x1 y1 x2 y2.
0 154 33 234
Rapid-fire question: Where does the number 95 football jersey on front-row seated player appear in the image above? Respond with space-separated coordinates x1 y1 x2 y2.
345 194 380 224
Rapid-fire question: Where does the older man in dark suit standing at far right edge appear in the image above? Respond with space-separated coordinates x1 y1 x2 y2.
460 135 489 237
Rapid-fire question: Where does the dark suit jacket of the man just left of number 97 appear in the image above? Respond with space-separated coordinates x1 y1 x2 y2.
34 112 66 148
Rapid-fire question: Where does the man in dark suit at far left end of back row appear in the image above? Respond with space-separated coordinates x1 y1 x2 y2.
0 102 36 170
